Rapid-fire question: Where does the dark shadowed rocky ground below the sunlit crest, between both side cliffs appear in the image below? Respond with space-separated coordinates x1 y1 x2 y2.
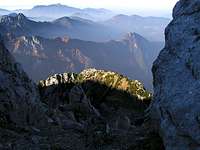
39 80 164 150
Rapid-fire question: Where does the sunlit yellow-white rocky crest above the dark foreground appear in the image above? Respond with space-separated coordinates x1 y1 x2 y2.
39 69 151 106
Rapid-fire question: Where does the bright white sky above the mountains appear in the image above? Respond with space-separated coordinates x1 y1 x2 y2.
0 0 178 16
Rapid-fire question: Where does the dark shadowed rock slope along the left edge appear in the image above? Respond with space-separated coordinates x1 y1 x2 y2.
0 42 46 149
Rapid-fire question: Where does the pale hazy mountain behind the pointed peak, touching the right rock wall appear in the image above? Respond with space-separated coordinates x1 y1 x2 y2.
103 14 170 41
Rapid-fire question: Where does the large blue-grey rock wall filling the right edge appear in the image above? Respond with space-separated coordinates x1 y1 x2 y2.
150 0 200 150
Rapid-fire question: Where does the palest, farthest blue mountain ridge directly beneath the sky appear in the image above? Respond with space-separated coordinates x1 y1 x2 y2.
14 4 115 21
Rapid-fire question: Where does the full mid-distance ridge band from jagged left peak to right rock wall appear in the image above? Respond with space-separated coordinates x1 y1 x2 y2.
0 13 169 42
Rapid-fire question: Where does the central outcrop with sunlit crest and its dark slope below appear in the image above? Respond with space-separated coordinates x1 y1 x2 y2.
39 69 162 150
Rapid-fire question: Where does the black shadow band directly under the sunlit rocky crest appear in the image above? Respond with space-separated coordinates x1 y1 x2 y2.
39 80 151 113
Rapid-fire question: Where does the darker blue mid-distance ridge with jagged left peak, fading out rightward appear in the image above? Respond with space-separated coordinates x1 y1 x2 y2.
0 13 117 41
